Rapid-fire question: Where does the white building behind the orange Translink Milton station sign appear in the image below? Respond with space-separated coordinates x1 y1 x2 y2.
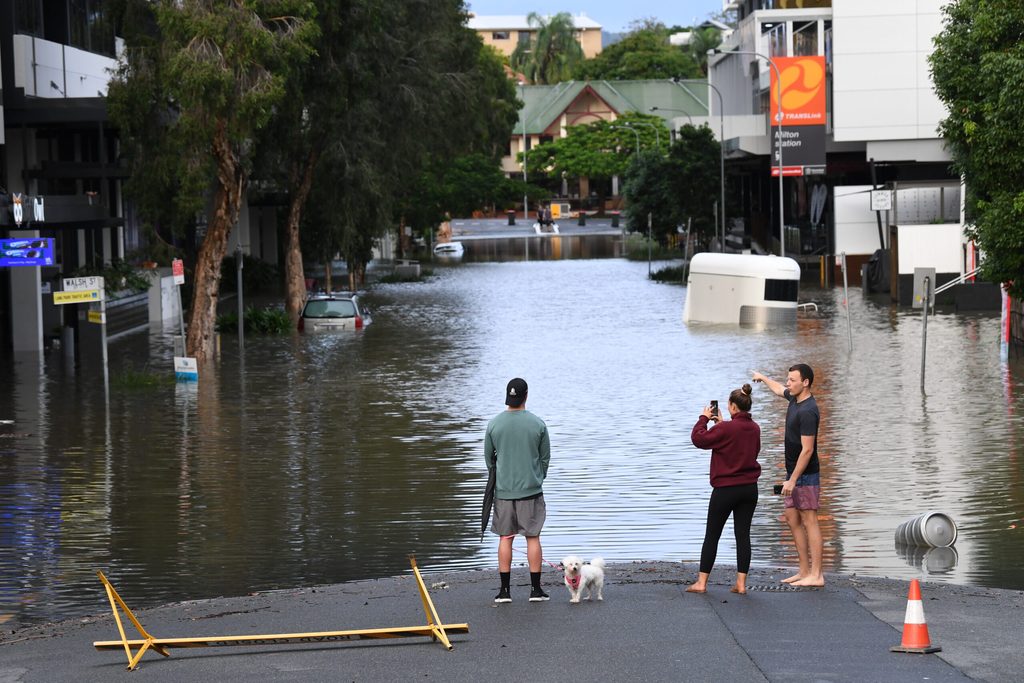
709 0 974 303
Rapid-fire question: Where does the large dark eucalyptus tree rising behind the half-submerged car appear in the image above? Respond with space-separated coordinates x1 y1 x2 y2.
260 0 516 299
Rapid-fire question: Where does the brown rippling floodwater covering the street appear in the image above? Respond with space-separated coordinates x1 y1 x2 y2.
0 258 1024 628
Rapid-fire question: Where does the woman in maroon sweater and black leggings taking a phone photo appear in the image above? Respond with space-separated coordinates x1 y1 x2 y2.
686 384 761 595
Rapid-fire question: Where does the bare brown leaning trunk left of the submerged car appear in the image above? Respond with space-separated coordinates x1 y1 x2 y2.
185 126 247 361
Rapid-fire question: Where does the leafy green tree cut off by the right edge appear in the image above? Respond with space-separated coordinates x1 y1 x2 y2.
930 0 1024 297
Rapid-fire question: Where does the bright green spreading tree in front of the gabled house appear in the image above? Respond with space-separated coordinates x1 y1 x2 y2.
520 112 669 178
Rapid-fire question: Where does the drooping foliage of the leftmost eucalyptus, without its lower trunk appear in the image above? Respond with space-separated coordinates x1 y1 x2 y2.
105 0 316 241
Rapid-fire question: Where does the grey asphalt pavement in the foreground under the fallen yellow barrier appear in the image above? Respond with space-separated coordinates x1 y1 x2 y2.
0 562 1024 683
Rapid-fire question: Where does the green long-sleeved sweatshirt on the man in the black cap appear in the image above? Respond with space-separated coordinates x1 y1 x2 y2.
483 411 551 501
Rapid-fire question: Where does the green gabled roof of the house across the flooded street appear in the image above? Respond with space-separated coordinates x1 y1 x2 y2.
513 79 710 135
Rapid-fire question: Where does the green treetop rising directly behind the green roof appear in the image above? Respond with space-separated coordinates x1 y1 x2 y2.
575 23 704 81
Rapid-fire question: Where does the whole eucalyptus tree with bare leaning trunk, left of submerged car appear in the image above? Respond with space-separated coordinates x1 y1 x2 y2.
109 0 318 359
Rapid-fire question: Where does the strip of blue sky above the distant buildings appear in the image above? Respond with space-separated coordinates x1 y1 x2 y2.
466 0 722 33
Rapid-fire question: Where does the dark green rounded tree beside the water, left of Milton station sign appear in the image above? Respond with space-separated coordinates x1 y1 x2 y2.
623 126 721 240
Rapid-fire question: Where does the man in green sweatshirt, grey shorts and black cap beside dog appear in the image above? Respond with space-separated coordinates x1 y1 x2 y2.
483 377 551 602
